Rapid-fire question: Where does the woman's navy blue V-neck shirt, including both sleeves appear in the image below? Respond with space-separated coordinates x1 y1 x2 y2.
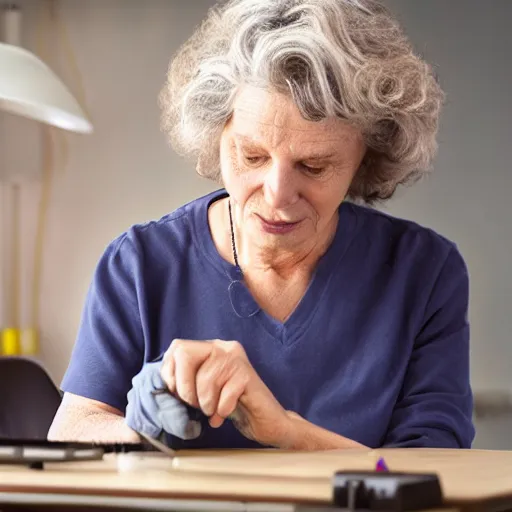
62 190 474 448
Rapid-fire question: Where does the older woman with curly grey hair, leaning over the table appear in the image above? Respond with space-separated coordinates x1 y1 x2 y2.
50 0 474 449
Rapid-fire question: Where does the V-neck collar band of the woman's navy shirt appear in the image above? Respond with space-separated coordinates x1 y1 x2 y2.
194 189 358 345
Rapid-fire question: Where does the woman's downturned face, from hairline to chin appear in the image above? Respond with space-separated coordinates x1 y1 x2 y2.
221 87 365 251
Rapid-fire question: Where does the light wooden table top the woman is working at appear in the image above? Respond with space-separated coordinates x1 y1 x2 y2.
0 449 512 512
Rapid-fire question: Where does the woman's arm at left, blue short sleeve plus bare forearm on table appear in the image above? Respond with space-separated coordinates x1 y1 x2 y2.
57 234 144 442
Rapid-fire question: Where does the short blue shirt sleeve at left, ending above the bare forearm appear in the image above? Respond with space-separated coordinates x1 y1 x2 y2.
61 234 144 412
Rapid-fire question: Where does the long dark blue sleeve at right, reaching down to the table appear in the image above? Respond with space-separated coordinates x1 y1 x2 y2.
384 247 475 448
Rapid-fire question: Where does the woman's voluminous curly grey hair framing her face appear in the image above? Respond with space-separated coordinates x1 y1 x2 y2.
160 0 444 203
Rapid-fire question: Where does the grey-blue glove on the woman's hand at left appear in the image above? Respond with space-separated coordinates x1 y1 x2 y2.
125 361 202 440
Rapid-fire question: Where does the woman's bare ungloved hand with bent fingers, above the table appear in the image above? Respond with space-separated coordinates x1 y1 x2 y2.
161 339 292 447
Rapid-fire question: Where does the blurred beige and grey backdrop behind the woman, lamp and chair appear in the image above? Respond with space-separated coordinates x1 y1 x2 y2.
0 0 512 449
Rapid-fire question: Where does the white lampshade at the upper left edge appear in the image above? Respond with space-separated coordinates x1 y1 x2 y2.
0 43 93 133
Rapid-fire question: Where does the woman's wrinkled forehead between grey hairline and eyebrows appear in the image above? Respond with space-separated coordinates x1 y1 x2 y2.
230 86 361 150
